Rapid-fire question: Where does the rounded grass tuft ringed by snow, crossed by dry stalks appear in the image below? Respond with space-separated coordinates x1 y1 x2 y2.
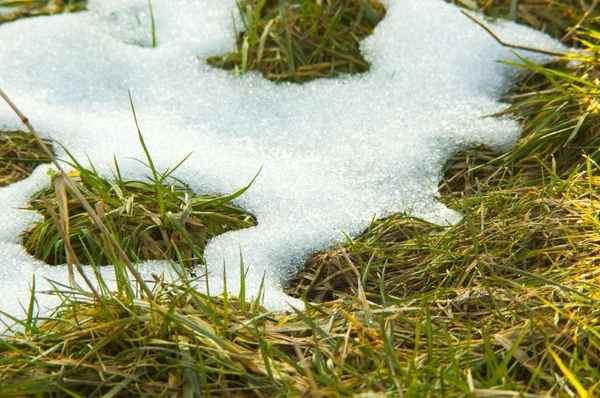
22 159 256 266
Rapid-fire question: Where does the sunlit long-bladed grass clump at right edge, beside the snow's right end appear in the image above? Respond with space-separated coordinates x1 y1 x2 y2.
506 30 600 171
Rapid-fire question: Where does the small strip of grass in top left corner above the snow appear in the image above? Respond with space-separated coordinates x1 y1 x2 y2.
0 0 87 24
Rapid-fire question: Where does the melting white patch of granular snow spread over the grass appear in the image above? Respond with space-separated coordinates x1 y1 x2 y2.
0 0 559 330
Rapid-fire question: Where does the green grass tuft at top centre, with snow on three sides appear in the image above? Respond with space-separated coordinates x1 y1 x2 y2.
207 0 385 83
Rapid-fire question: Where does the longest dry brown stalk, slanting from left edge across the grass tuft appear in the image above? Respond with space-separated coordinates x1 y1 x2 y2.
0 89 154 301
